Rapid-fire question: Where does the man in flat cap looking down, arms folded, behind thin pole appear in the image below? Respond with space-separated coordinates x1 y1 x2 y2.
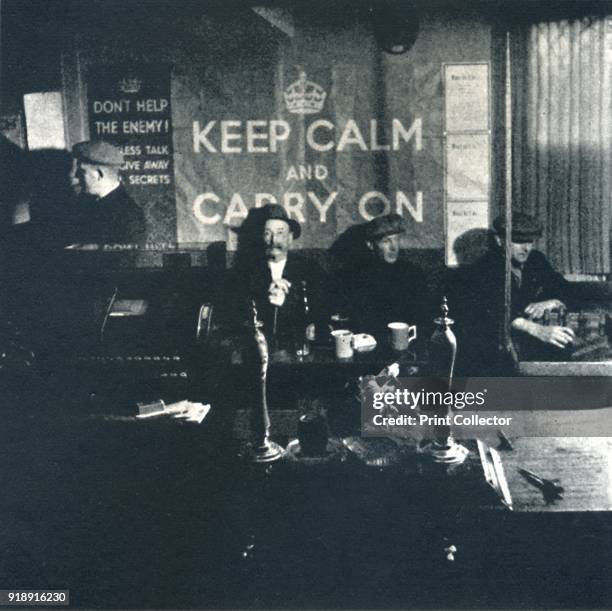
457 212 575 369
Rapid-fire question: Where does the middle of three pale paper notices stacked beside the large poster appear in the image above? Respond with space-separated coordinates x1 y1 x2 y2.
446 134 491 201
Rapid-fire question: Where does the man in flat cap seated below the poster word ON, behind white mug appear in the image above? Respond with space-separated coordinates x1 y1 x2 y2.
343 214 433 340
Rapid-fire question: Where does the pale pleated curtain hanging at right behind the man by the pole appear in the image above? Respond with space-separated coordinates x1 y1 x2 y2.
511 17 612 274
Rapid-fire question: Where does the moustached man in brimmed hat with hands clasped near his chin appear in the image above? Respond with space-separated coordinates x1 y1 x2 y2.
232 204 326 338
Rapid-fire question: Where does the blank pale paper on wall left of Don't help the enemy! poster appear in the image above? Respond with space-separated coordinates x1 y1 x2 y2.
23 91 66 151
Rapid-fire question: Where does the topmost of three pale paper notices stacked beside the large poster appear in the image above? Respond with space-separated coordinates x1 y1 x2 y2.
444 63 489 133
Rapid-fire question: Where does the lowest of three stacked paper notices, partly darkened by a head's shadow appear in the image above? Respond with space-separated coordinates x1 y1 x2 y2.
446 201 489 267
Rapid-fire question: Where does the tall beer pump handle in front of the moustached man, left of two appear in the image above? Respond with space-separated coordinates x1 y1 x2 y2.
247 301 283 463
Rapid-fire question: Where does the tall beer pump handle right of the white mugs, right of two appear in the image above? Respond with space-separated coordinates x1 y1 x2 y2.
425 297 469 464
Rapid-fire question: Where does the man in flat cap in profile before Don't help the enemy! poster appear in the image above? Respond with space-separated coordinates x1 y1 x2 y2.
72 140 145 245
